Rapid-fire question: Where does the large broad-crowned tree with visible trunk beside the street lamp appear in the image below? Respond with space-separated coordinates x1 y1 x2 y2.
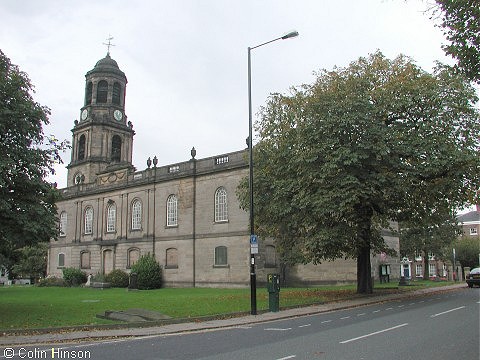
238 52 480 293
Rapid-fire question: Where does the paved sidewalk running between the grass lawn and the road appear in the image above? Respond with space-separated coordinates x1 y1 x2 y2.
0 283 467 346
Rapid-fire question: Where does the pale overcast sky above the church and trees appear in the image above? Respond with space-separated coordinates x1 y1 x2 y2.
0 0 451 187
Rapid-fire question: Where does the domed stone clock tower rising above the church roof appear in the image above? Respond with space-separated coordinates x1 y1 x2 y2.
67 49 135 186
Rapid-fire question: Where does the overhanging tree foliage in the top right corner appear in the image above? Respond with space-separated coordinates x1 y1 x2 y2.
433 0 480 83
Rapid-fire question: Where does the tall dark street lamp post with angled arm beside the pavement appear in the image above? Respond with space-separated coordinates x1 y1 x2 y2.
248 31 298 315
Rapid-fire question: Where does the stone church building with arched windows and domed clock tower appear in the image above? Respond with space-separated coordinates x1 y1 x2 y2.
47 53 400 287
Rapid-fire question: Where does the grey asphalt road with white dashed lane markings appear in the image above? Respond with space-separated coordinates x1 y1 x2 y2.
4 288 480 360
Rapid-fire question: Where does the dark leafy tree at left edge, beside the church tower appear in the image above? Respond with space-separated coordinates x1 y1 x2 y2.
0 51 67 259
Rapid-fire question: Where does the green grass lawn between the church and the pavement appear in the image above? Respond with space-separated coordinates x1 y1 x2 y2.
0 282 454 330
